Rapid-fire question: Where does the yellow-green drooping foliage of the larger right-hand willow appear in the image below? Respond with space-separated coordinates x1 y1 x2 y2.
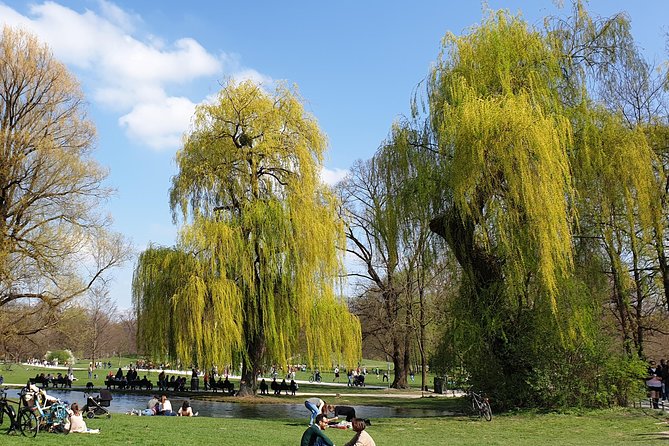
431 13 574 309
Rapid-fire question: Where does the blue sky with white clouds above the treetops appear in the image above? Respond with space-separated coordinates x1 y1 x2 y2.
0 0 669 308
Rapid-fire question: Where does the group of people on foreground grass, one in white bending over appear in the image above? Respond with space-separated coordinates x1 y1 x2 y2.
300 397 376 446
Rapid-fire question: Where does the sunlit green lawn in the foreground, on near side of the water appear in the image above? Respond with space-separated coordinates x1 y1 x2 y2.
0 409 669 446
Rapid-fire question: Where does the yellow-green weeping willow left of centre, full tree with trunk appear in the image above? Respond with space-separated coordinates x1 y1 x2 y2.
133 81 361 393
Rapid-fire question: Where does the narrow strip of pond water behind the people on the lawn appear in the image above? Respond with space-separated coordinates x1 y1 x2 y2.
7 389 453 420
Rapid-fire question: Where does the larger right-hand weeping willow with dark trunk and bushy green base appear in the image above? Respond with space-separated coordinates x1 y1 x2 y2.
427 3 654 405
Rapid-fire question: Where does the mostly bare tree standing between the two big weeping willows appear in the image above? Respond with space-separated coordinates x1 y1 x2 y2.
340 126 438 388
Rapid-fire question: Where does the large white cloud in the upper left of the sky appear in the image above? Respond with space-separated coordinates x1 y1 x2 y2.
0 0 272 149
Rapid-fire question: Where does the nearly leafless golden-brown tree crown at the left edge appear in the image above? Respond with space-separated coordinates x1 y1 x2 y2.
0 27 128 335
